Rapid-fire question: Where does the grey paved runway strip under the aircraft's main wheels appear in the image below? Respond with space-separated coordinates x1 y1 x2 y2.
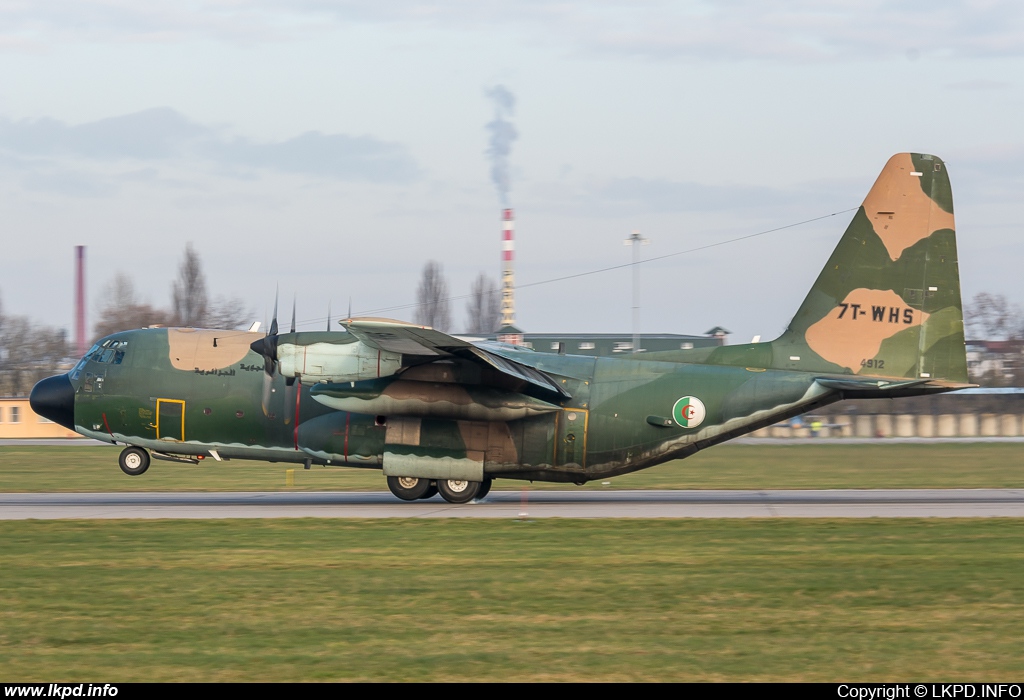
0 489 1024 520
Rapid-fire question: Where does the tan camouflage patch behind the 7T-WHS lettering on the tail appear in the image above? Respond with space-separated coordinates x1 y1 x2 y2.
805 289 929 375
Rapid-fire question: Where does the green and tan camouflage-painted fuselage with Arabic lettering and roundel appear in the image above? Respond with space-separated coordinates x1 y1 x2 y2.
71 329 838 482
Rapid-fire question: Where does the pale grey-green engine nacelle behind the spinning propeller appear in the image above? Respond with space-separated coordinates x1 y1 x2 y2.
278 342 401 384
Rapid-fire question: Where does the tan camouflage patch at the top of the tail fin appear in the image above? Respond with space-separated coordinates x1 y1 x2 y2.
863 154 954 261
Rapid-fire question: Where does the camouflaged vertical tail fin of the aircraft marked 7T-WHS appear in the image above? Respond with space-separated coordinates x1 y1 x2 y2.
711 154 968 385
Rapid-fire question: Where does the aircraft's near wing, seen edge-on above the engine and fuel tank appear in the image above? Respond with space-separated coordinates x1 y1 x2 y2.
341 318 569 398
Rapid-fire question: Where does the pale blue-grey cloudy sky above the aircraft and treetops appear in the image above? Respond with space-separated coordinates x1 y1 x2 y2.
0 0 1024 343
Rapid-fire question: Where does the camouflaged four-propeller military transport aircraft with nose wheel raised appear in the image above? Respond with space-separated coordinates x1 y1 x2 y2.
31 154 970 504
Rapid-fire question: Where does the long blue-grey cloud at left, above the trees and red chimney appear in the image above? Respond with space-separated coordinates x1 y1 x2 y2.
0 107 419 183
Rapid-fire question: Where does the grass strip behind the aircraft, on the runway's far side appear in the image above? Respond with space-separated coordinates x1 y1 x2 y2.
0 442 1024 492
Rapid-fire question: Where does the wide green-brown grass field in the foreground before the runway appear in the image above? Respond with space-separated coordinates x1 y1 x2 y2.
0 519 1024 683
